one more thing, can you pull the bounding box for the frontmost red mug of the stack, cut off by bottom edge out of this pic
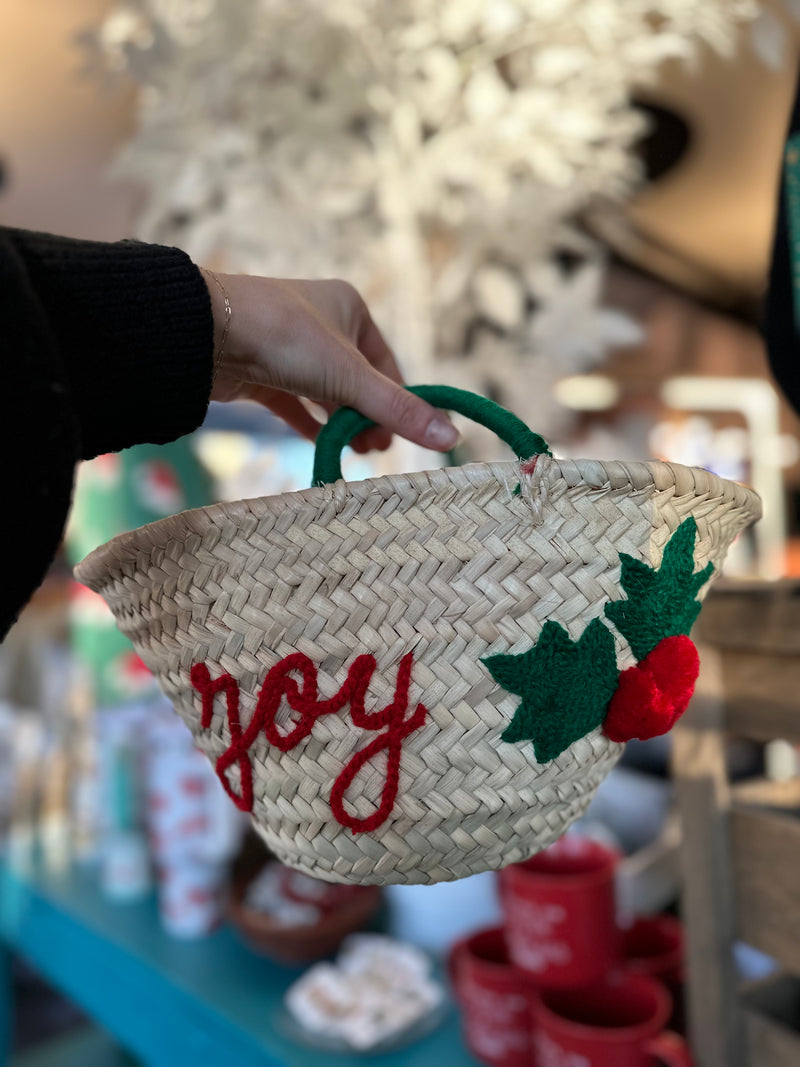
[531,972,692,1067]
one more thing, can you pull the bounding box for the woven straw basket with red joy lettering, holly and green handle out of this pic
[76,386,761,885]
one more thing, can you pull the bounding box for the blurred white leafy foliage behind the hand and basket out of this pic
[87,0,758,446]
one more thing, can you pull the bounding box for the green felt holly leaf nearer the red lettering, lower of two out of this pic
[482,619,619,763]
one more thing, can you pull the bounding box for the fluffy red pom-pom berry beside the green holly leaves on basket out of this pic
[603,634,700,742]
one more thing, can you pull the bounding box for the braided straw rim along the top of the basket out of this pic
[74,457,762,591]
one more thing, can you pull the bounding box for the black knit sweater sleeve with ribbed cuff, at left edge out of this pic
[0,227,213,638]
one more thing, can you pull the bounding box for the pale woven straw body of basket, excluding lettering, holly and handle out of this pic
[77,456,759,883]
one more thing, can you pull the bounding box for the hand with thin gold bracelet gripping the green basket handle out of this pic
[204,271,459,451]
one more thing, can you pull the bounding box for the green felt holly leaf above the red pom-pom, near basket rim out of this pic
[605,519,714,660]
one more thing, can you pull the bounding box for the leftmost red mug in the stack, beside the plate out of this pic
[448,926,533,1067]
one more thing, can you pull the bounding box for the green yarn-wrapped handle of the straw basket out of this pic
[311,385,551,485]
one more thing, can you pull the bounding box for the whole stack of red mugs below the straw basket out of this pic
[449,834,692,1067]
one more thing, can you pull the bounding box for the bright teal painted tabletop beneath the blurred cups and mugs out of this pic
[0,867,477,1067]
